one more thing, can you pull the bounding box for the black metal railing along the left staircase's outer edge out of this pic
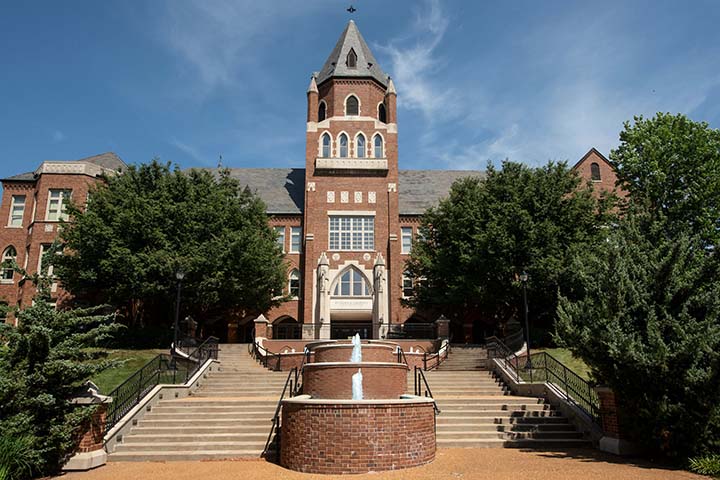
[105,337,218,432]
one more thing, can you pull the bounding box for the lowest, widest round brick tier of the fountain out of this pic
[280,397,435,475]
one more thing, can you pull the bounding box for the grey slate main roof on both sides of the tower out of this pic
[225,168,485,215]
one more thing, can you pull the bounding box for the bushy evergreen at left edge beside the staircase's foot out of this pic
[0,279,118,480]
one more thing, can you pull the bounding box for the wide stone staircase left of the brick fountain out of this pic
[108,345,287,462]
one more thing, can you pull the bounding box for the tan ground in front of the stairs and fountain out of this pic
[58,448,706,480]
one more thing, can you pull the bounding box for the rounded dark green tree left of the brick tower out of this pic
[55,160,286,325]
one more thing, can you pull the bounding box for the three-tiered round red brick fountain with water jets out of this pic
[279,335,435,475]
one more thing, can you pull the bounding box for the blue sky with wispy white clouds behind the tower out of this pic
[0,0,720,177]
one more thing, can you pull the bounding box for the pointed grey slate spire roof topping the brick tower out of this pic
[317,20,388,87]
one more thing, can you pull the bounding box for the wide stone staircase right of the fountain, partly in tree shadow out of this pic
[416,347,591,448]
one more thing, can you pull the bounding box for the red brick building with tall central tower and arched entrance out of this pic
[0,21,616,341]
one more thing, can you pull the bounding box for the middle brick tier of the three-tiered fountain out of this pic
[303,362,408,400]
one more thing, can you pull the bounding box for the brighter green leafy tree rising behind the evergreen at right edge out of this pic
[610,113,720,243]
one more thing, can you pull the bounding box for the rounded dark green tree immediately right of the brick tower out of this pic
[408,161,611,338]
